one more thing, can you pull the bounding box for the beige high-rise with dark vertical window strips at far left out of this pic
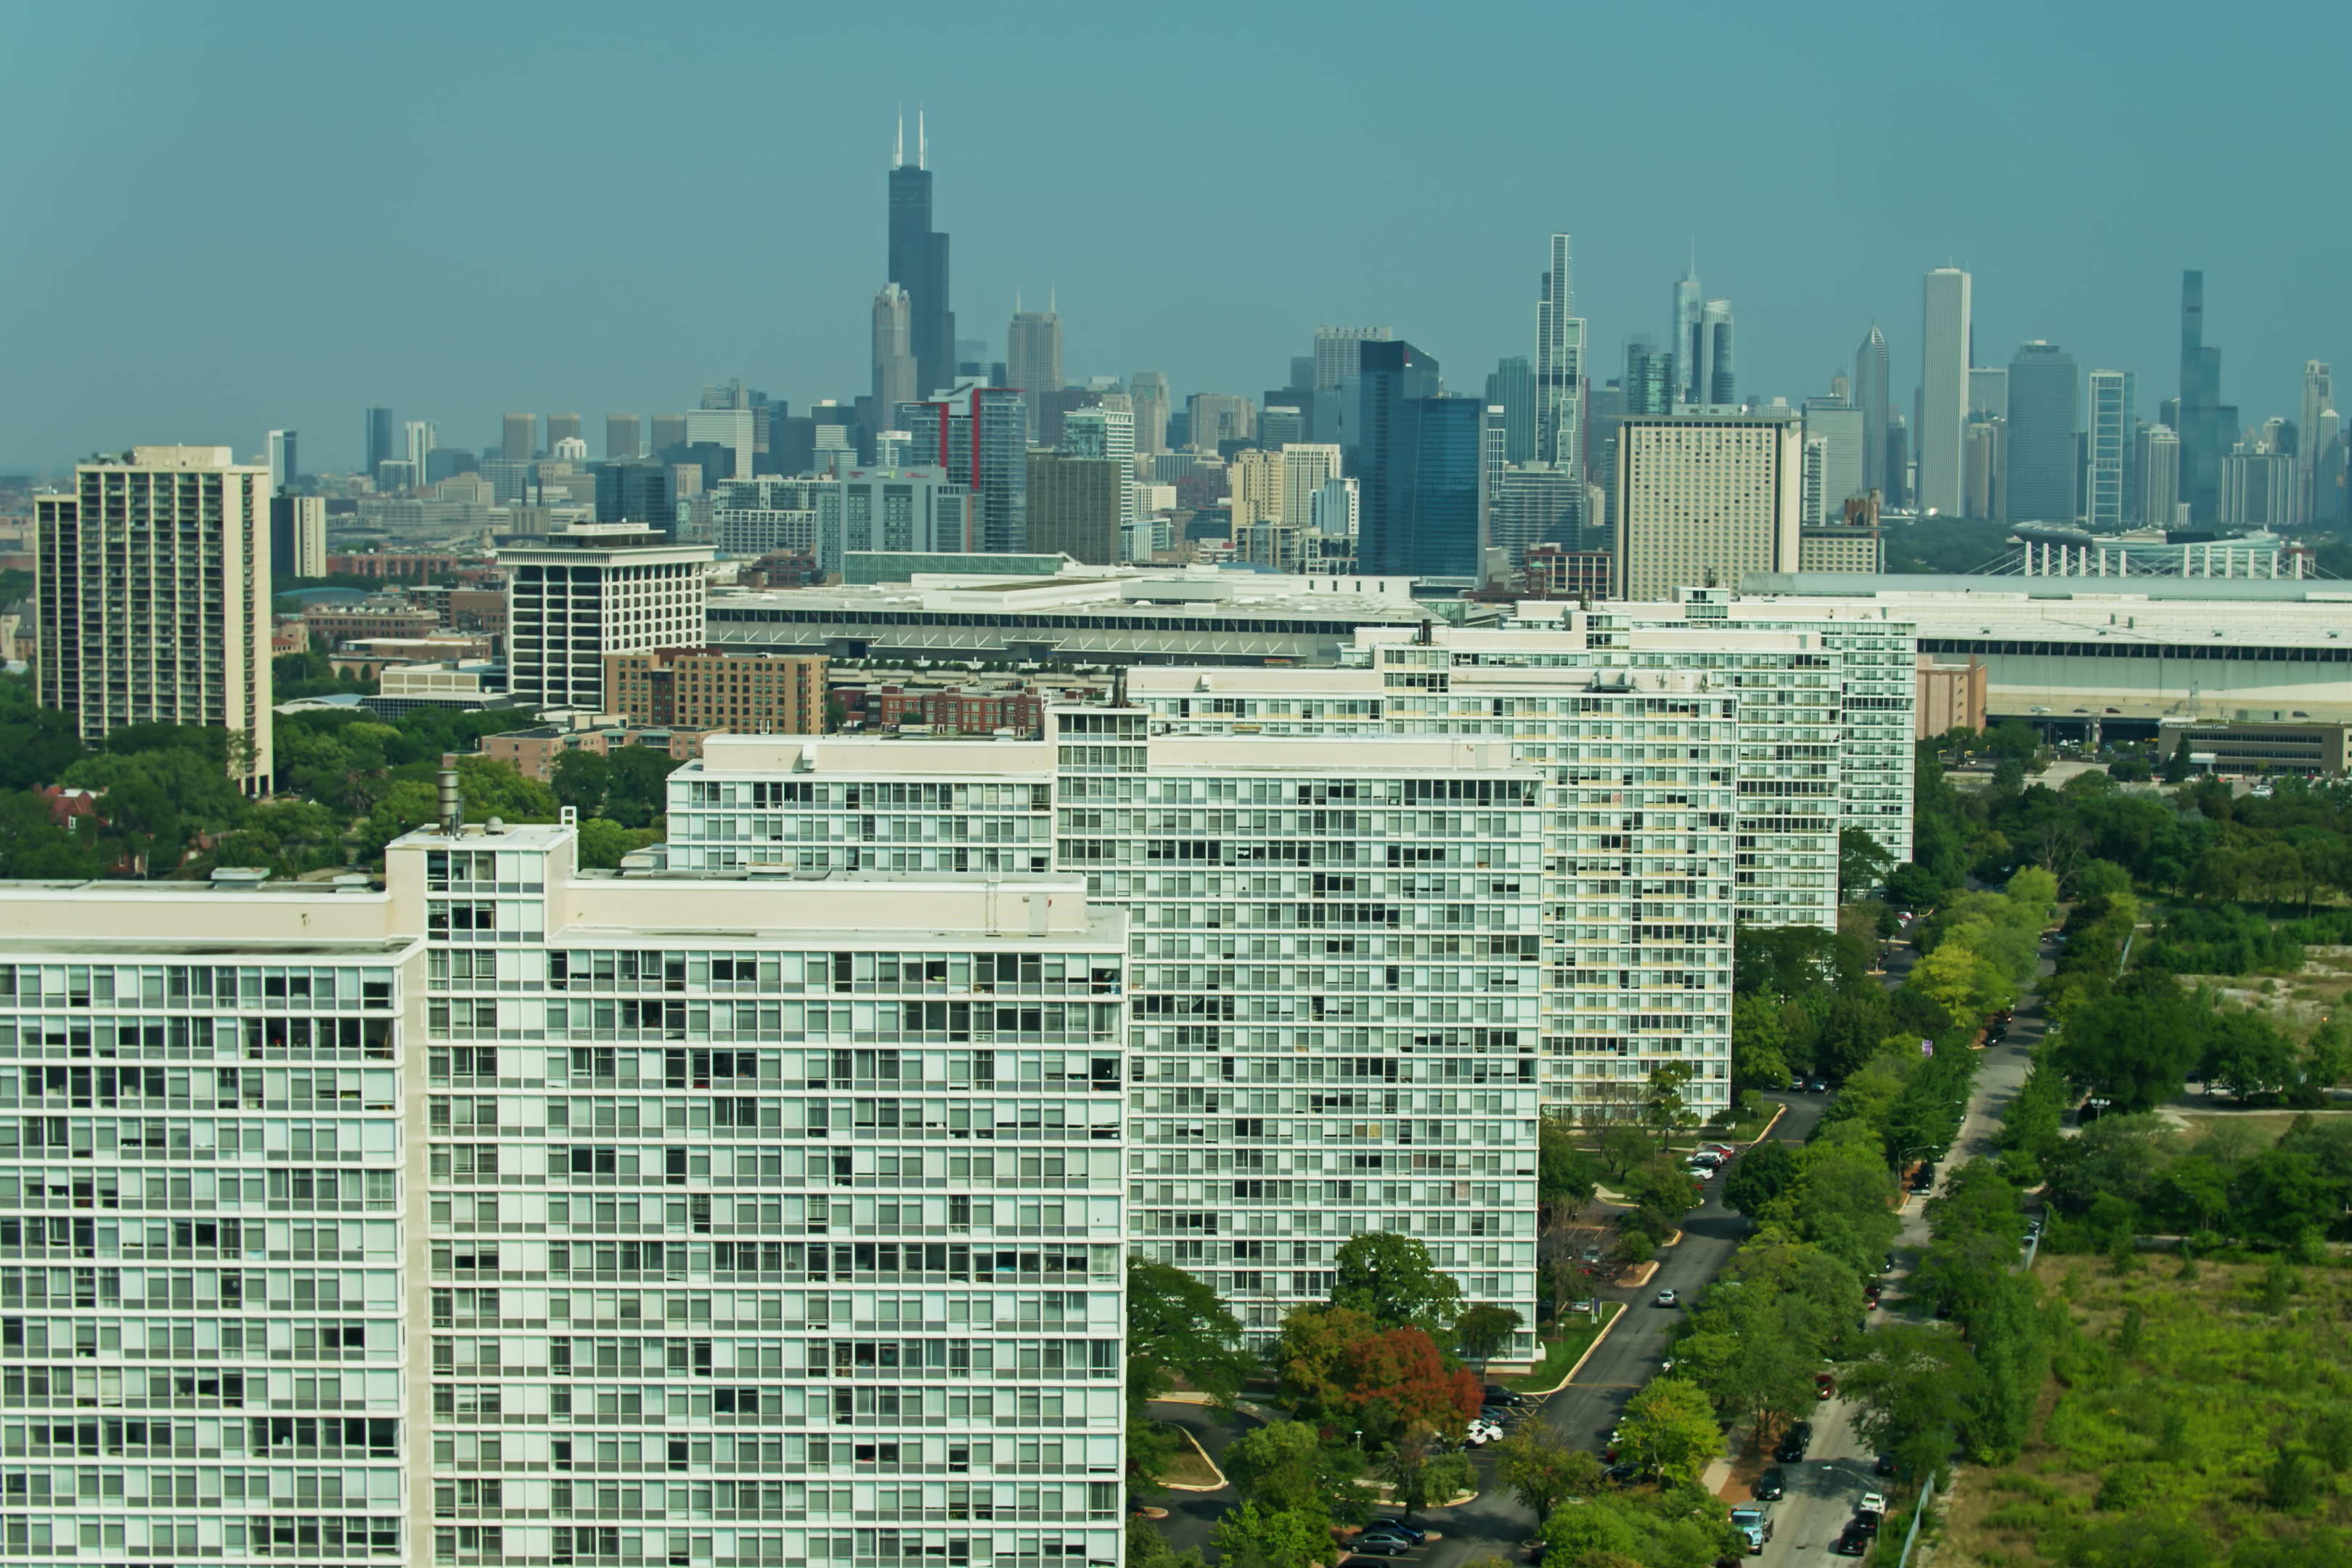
[33,446,273,783]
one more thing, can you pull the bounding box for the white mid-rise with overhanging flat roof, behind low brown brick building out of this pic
[499,522,713,712]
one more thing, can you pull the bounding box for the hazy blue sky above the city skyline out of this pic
[0,0,2352,470]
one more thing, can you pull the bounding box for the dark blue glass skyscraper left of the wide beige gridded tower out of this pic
[1350,338,1487,579]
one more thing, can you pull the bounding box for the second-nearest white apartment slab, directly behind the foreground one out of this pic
[668,724,1540,1357]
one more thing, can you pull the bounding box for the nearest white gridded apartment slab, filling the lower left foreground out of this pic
[0,817,1129,1568]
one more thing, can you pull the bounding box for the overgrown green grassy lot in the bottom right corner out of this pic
[1936,1258,2352,1568]
